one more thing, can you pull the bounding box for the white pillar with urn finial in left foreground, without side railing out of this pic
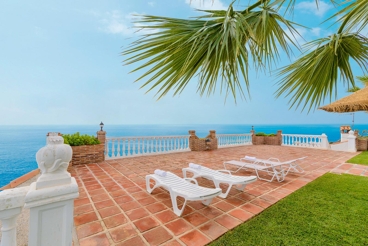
[25,133,79,246]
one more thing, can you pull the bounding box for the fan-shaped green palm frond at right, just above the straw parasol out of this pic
[276,33,368,111]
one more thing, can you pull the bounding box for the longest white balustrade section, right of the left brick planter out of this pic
[105,135,190,160]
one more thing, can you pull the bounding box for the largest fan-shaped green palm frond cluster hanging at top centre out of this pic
[122,2,297,100]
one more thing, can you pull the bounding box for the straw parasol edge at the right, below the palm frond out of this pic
[319,86,368,113]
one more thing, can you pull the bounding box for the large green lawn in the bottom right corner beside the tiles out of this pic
[210,173,368,246]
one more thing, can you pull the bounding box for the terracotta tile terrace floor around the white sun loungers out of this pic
[71,145,368,246]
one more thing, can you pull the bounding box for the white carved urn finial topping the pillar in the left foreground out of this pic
[36,132,73,189]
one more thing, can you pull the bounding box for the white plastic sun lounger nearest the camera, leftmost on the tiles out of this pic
[146,169,222,216]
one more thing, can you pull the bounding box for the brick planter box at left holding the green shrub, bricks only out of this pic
[69,144,105,166]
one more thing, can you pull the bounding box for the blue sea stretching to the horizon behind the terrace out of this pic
[0,124,368,187]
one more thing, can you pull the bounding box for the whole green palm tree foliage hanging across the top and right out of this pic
[122,0,368,110]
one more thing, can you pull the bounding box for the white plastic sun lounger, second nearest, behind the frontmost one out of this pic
[183,163,257,198]
